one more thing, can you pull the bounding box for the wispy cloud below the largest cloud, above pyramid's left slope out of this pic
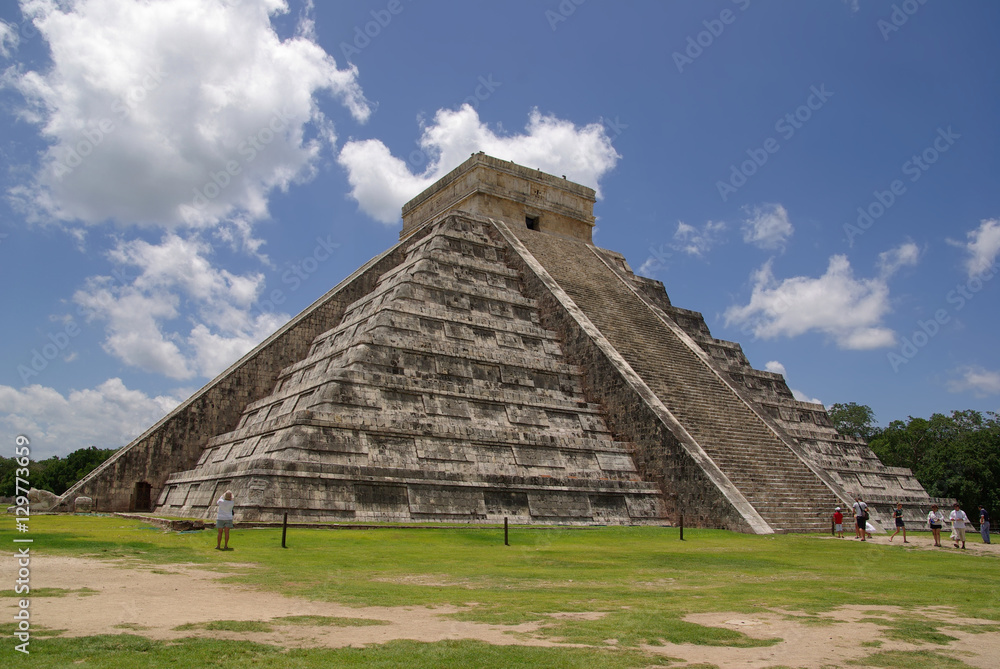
[73,234,288,379]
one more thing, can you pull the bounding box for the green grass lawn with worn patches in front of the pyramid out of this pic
[0,516,1000,669]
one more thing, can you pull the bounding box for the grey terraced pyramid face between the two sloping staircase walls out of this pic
[160,218,662,523]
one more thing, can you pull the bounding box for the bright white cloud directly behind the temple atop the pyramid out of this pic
[338,104,620,224]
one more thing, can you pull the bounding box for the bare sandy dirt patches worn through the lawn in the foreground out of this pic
[0,535,1000,668]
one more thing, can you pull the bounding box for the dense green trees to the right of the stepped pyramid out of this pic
[828,402,1000,518]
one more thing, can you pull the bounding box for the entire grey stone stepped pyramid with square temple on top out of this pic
[56,153,952,533]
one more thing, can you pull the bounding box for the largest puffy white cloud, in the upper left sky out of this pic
[4,0,369,227]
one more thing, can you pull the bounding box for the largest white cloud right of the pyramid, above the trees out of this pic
[725,255,895,349]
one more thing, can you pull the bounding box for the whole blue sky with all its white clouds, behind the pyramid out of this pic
[0,0,1000,458]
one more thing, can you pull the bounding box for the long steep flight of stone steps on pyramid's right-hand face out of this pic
[515,228,843,532]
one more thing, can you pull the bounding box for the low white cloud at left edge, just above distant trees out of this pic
[0,378,180,460]
